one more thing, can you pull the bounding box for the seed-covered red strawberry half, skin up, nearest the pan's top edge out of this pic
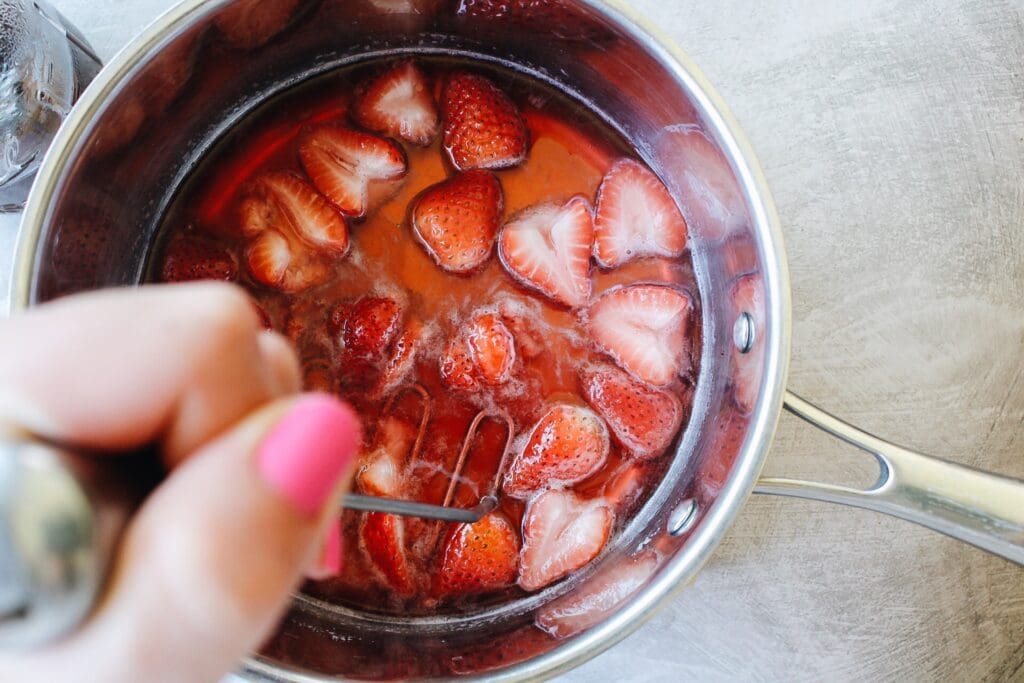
[441,73,529,171]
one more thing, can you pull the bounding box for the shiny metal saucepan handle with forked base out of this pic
[754,391,1024,565]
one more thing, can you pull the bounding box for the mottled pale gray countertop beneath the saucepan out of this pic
[0,0,1024,683]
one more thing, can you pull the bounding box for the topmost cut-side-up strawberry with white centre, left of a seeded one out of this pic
[352,61,439,146]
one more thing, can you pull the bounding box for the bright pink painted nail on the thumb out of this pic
[257,394,361,519]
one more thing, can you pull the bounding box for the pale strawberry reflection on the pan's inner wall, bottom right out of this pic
[537,550,657,639]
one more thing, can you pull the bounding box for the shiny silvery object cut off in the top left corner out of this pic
[0,0,100,211]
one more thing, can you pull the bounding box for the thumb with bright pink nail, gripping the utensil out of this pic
[83,394,360,681]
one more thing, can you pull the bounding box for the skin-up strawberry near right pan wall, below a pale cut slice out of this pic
[584,365,683,460]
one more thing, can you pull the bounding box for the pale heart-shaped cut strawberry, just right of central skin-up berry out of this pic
[498,197,594,308]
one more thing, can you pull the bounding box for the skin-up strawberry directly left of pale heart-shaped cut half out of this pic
[413,171,504,273]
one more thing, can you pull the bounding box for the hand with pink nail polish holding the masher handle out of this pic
[0,284,360,682]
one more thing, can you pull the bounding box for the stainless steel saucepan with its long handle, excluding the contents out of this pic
[12,0,1024,681]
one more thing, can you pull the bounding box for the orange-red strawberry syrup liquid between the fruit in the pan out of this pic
[151,57,699,613]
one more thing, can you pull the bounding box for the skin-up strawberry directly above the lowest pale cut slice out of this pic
[502,405,608,498]
